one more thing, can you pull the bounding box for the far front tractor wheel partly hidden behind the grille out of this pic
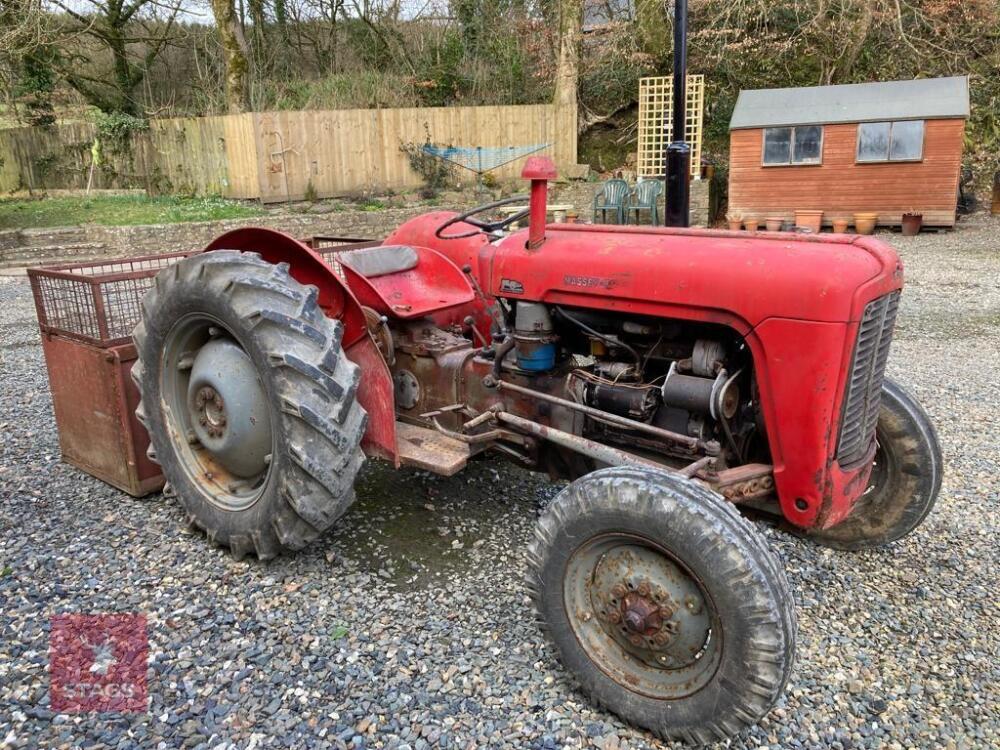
[808,378,944,551]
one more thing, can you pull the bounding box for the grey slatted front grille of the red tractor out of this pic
[837,292,899,466]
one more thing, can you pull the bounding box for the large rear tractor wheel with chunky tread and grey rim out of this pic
[132,251,367,559]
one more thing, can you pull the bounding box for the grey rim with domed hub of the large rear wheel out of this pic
[160,314,274,511]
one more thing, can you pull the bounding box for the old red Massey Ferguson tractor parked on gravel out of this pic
[133,158,942,743]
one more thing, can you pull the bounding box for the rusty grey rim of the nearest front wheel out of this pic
[564,533,722,699]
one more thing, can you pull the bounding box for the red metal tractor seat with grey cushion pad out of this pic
[334,245,475,319]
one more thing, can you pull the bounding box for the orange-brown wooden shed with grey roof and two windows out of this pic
[729,76,969,227]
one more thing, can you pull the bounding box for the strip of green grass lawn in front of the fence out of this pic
[0,195,263,229]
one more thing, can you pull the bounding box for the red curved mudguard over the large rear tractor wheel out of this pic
[205,227,399,466]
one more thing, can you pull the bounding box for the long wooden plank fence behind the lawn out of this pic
[0,104,577,202]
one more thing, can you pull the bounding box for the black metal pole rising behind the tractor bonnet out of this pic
[664,0,691,227]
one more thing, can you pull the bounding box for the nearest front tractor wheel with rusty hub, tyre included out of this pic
[528,467,796,744]
